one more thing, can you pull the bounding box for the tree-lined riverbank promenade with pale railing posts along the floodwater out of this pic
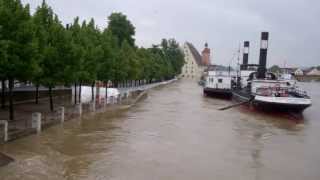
[0,79,176,166]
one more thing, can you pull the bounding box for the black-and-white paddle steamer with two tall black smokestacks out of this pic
[232,32,312,112]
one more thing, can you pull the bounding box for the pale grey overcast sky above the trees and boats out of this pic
[23,0,320,67]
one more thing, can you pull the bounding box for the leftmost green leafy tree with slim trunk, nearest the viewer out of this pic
[0,0,37,120]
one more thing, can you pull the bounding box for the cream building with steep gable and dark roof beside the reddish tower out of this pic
[181,42,206,79]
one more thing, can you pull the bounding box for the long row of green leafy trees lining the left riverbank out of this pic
[0,0,184,120]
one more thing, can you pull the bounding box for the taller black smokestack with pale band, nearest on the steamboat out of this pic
[258,32,269,79]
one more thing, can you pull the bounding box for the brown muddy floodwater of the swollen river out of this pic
[0,81,320,180]
